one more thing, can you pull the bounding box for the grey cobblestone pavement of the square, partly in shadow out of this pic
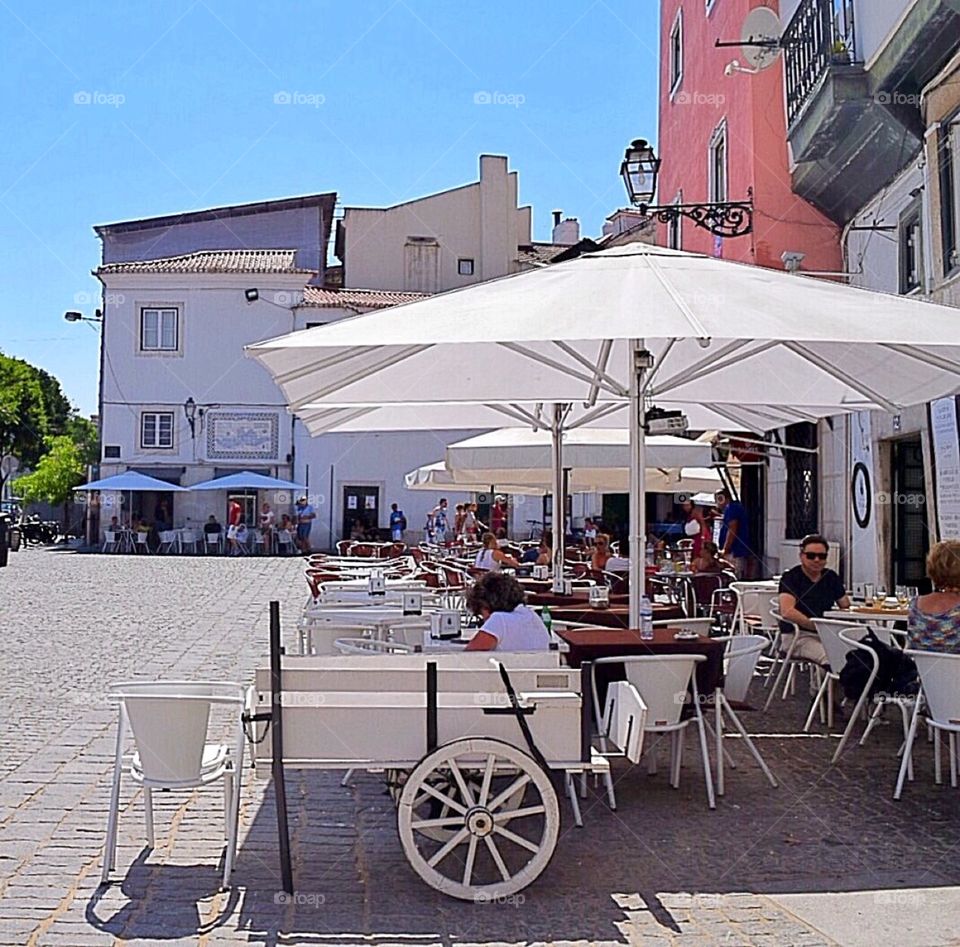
[0,550,960,947]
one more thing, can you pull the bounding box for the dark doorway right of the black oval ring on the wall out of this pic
[891,437,930,591]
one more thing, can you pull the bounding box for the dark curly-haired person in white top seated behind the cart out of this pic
[466,572,550,651]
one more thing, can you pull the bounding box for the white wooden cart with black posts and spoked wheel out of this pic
[249,608,644,902]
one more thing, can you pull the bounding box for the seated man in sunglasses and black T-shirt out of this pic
[779,533,850,664]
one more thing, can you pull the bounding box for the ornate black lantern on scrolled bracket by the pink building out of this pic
[620,138,753,237]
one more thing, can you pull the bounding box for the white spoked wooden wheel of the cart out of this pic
[397,737,560,901]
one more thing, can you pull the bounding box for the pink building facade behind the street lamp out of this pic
[656,0,843,273]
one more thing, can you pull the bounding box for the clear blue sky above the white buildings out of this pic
[0,0,658,413]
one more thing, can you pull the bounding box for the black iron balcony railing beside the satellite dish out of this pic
[783,0,856,126]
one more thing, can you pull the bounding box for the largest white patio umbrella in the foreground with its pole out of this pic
[249,244,960,623]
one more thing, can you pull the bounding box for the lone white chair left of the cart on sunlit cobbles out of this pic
[101,681,246,887]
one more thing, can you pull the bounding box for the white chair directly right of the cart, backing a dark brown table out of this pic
[592,654,717,809]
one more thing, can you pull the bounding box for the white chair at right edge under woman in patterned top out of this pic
[893,648,960,799]
